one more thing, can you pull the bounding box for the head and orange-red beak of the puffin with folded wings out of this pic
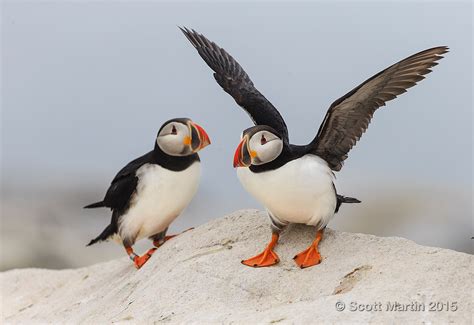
[156,118,211,157]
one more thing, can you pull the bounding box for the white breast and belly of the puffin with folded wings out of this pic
[119,162,201,242]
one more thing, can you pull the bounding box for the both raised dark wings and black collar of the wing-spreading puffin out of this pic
[180,28,448,172]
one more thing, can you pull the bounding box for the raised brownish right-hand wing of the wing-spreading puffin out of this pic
[308,46,448,171]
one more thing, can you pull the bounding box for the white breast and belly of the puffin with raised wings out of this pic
[237,155,336,225]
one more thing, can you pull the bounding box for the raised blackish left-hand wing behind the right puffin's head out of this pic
[180,27,288,140]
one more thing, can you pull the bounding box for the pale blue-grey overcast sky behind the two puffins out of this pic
[1,1,472,256]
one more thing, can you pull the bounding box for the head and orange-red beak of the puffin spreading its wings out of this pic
[234,125,283,167]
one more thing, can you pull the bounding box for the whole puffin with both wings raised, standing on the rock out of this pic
[180,28,448,268]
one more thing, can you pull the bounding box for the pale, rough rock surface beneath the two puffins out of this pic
[0,210,473,324]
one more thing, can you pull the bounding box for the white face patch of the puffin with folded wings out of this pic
[156,122,191,156]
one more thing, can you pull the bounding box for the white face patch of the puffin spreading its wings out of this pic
[248,131,283,165]
